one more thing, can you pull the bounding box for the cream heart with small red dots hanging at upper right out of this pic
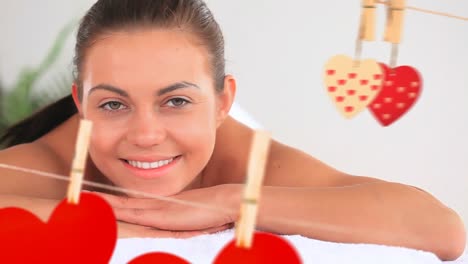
[324,55,384,118]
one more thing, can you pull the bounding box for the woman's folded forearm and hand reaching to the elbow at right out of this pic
[90,179,465,260]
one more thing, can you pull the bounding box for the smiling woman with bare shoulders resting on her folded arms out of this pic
[0,0,465,260]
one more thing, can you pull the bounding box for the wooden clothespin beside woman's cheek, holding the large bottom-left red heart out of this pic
[67,119,92,204]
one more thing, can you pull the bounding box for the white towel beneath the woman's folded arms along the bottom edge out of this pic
[111,229,468,264]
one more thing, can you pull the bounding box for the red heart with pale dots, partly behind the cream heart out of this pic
[367,63,422,126]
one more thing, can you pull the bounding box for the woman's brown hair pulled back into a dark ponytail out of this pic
[0,0,225,147]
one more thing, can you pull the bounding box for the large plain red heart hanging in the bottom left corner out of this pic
[0,193,117,263]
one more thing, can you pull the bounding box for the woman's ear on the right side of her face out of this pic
[216,75,237,127]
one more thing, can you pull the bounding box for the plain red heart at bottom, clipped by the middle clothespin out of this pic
[214,232,302,264]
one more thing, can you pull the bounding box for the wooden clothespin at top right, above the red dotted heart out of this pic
[384,0,406,44]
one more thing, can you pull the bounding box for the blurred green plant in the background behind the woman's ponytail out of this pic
[0,22,76,135]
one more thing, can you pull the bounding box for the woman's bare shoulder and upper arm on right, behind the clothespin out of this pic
[207,117,380,187]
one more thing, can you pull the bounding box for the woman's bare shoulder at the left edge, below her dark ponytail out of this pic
[0,141,66,199]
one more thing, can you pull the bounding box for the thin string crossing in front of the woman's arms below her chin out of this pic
[0,163,322,230]
